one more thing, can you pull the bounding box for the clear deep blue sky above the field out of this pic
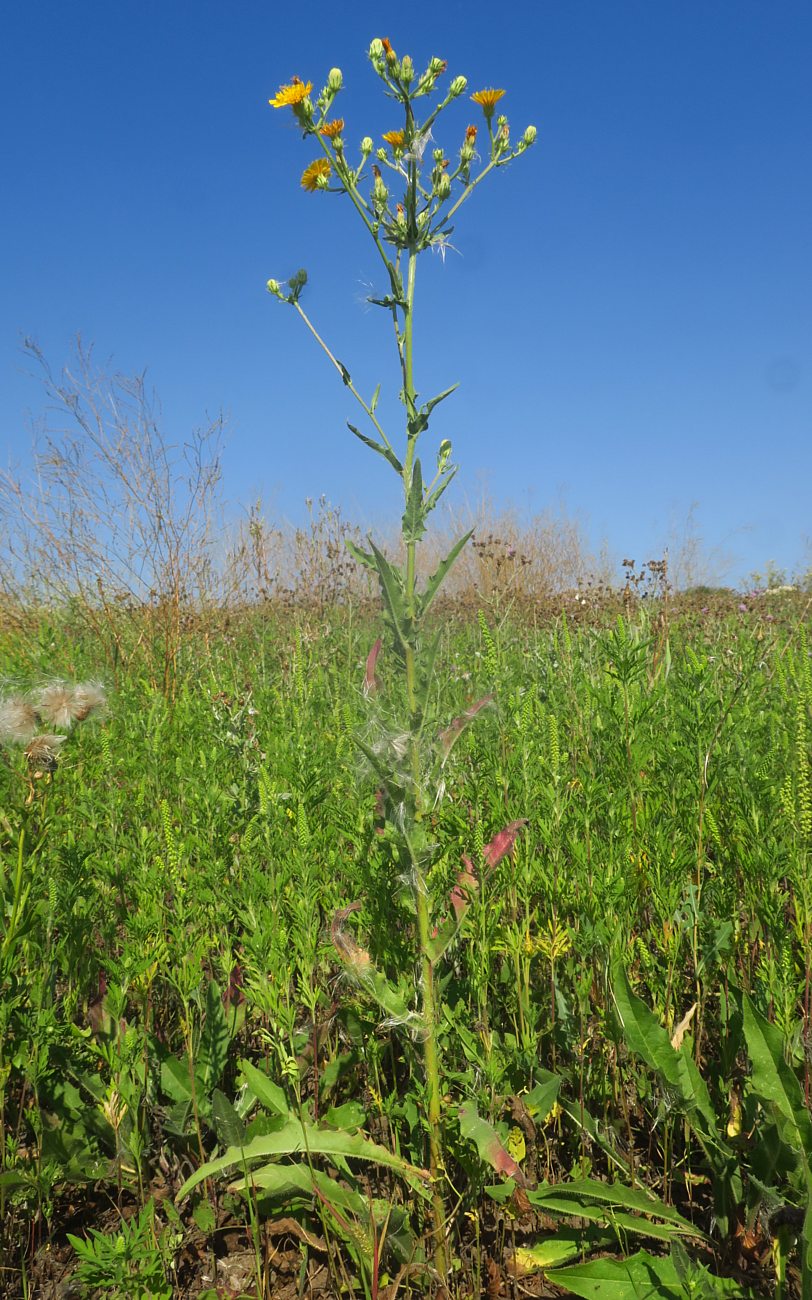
[0,0,812,580]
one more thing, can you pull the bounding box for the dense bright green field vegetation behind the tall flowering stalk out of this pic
[0,607,812,1295]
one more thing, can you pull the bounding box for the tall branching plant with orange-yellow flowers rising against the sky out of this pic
[268,39,535,1277]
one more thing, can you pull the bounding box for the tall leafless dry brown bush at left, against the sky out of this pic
[0,339,222,696]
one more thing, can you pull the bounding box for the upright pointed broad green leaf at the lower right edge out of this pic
[742,996,812,1170]
